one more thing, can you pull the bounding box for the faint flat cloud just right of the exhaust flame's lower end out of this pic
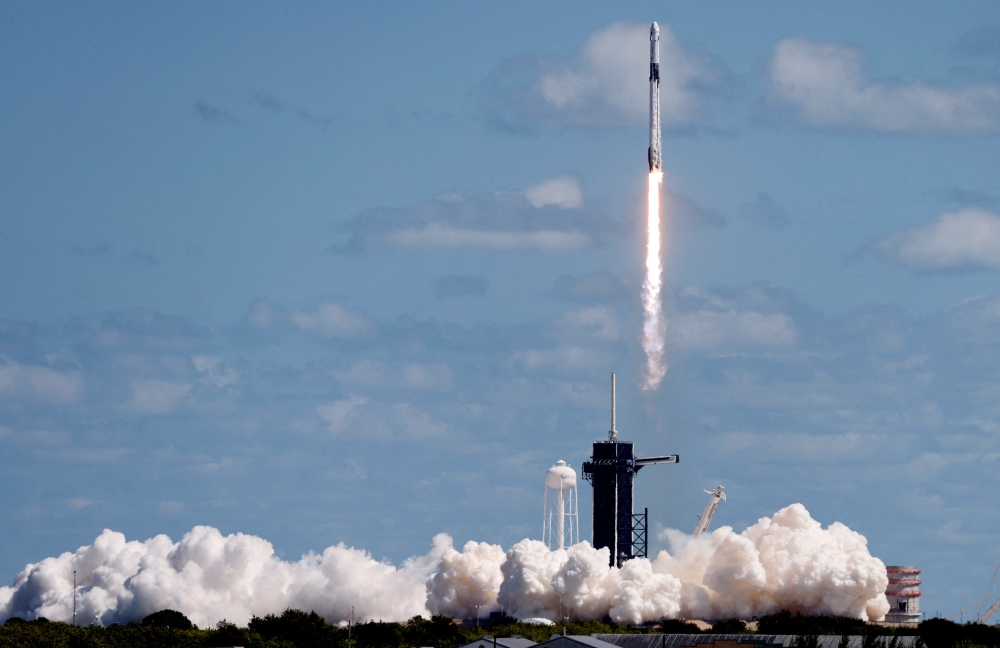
[667,310,798,351]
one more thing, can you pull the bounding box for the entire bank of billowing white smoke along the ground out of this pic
[0,504,889,627]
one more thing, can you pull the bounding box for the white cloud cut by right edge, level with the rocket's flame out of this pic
[874,207,1000,270]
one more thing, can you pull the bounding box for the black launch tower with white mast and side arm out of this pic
[583,374,680,567]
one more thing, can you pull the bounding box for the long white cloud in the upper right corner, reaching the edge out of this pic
[770,37,1000,135]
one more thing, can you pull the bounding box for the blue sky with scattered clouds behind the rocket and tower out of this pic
[0,2,1000,614]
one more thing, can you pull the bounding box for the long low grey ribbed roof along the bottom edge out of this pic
[592,634,919,648]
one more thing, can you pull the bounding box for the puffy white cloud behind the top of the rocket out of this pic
[529,23,710,126]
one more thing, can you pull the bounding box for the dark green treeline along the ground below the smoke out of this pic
[0,610,1000,648]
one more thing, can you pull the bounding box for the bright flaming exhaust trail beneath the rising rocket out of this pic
[642,171,667,390]
